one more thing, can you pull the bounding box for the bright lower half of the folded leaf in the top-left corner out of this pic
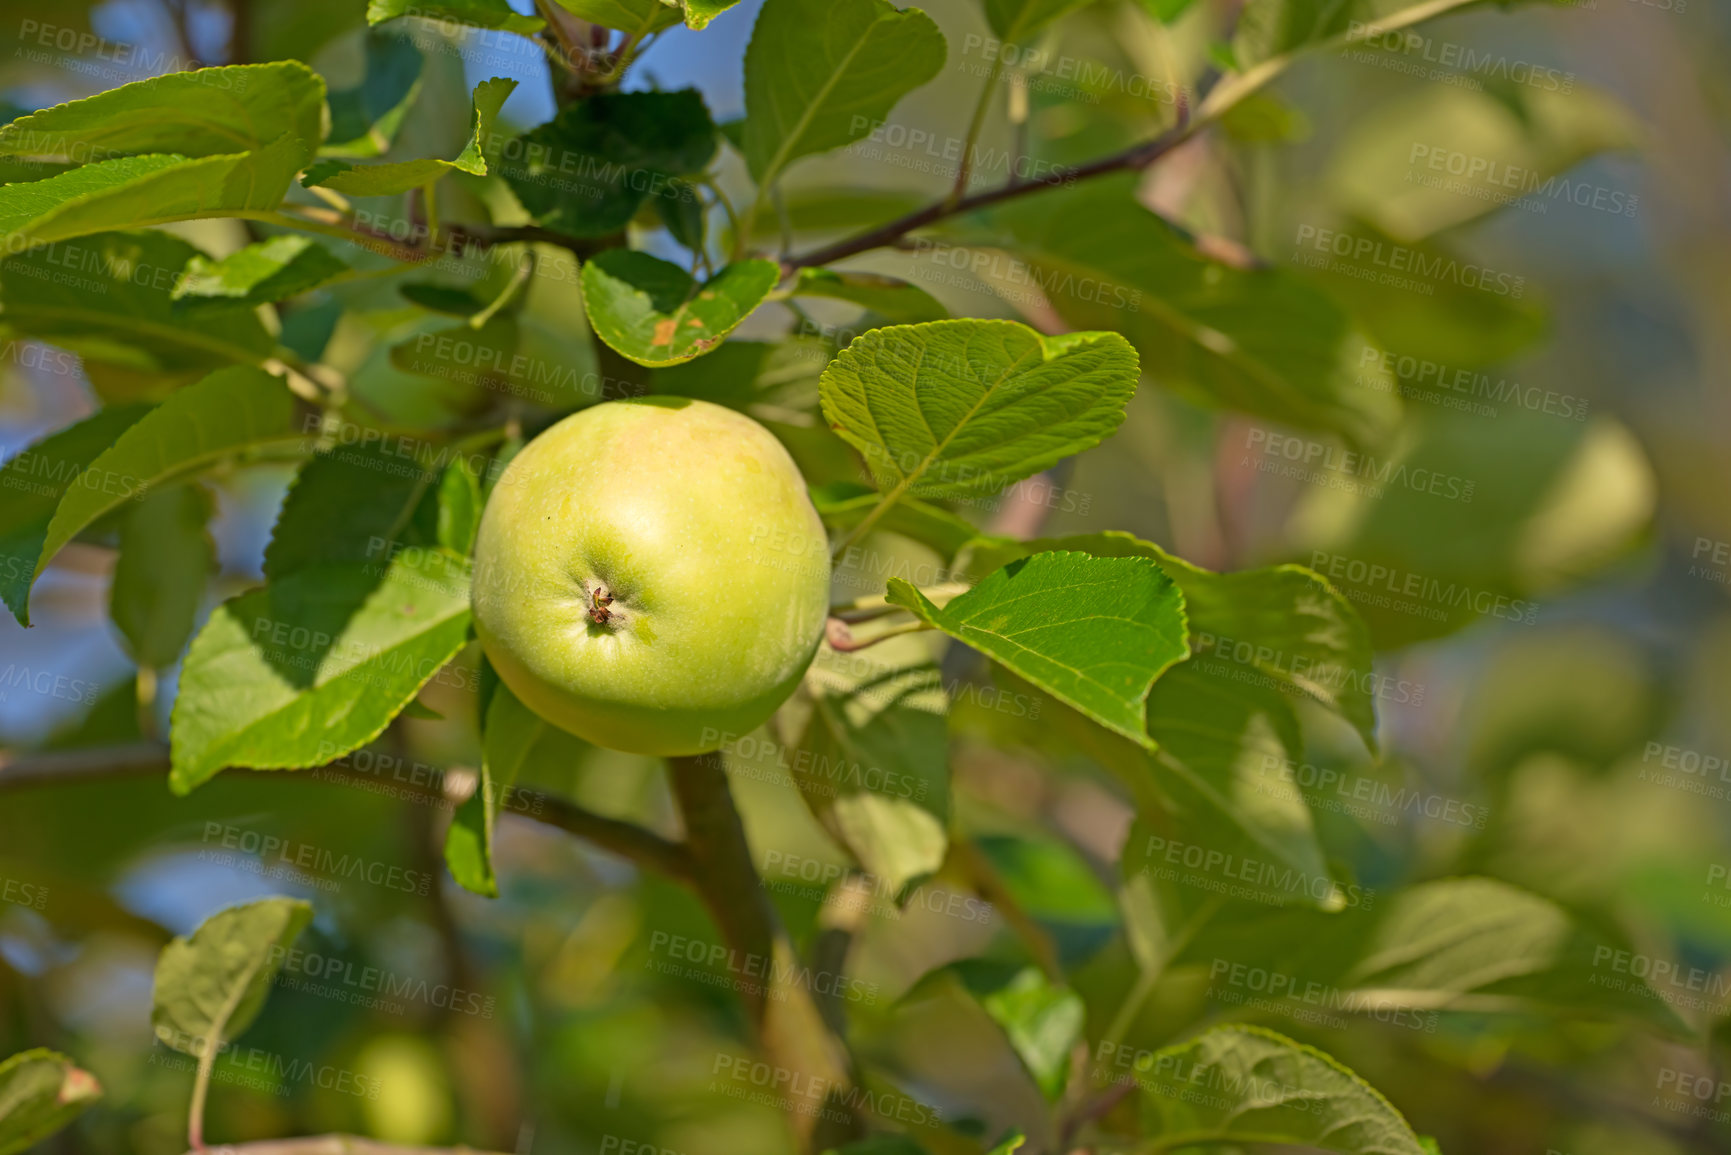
[0,135,306,253]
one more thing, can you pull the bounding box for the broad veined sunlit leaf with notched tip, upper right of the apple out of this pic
[820,320,1137,500]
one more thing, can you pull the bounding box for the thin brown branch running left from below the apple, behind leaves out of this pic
[0,743,691,880]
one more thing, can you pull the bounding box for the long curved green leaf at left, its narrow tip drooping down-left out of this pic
[14,367,301,625]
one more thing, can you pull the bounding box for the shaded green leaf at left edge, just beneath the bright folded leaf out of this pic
[0,230,272,398]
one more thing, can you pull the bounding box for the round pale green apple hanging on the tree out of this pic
[473,397,829,757]
